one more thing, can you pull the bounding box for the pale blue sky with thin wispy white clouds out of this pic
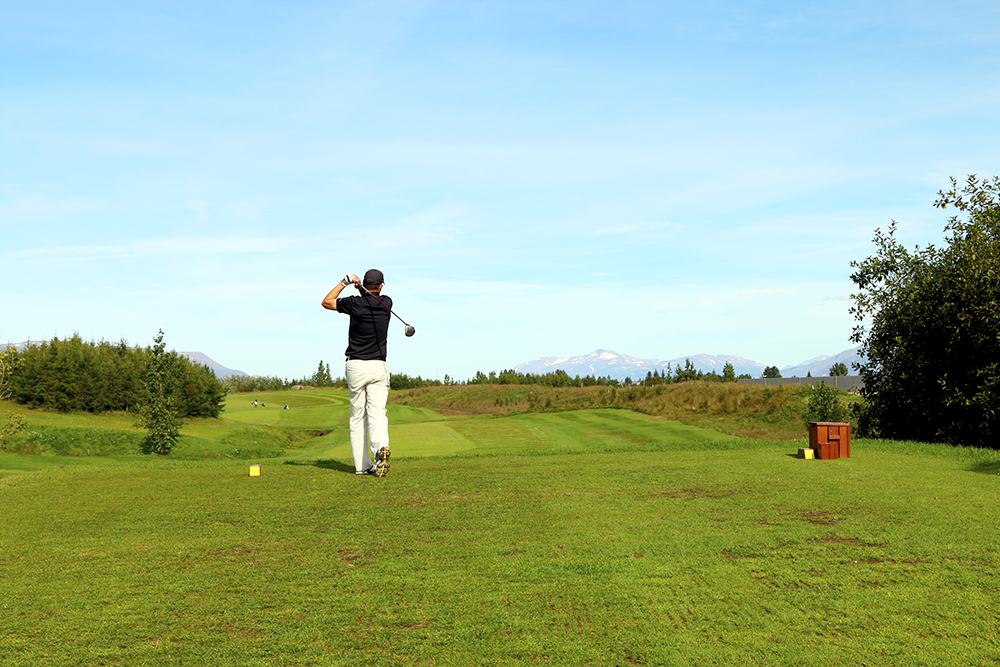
[0,0,1000,379]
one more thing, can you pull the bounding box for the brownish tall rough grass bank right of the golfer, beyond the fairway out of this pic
[390,381,809,439]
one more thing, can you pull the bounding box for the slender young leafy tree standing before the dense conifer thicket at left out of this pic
[139,329,181,455]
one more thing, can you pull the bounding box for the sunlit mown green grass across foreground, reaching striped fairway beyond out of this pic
[0,393,1000,665]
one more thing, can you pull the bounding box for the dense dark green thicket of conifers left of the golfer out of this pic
[7,334,225,418]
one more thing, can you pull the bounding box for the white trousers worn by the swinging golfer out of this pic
[345,359,389,472]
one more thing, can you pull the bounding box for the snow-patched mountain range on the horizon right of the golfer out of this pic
[514,348,858,380]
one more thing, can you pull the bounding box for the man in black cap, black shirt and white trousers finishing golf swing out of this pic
[323,269,392,477]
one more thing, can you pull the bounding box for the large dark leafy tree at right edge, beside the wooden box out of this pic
[851,176,1000,448]
